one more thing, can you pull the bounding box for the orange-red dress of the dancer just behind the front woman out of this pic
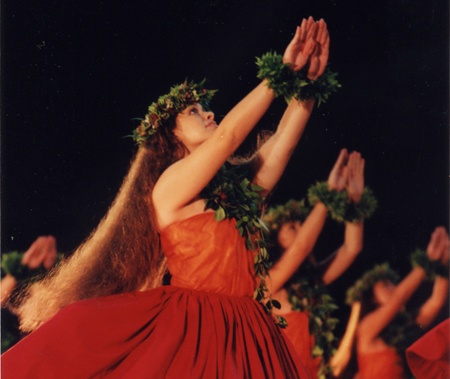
[283,311,320,378]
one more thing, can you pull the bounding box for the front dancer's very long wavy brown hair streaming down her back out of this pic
[17,119,186,332]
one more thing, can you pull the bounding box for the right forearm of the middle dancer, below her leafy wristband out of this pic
[322,222,364,284]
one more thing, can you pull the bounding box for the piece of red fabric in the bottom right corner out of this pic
[406,319,450,379]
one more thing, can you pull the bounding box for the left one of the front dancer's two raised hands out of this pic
[283,17,318,71]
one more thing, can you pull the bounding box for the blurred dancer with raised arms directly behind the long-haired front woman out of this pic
[264,149,367,378]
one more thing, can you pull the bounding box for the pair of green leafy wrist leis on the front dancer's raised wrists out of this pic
[256,52,341,106]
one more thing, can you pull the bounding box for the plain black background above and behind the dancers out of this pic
[1,0,449,326]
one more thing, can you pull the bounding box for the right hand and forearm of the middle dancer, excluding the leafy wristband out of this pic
[322,152,365,284]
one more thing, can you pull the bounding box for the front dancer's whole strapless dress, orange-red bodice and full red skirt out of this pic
[1,213,309,379]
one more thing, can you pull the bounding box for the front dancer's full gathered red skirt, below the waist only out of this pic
[2,286,309,379]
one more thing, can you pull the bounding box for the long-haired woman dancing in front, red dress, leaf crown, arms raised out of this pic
[2,18,338,378]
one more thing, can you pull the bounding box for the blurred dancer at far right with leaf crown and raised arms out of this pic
[348,227,449,379]
